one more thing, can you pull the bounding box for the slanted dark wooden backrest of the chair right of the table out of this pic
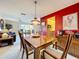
[61,34,73,59]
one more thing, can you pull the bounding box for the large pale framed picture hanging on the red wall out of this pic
[63,12,78,30]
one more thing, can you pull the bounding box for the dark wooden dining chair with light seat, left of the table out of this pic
[18,32,34,59]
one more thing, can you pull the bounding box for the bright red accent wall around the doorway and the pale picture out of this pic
[41,3,79,31]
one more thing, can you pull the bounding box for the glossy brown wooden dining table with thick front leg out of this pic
[24,36,54,59]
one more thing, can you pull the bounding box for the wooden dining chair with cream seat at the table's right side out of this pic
[43,34,73,59]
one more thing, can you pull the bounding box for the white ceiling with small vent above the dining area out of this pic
[0,0,79,22]
